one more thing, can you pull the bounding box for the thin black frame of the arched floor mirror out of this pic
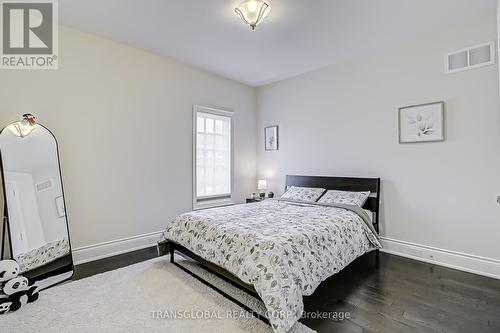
[0,122,75,290]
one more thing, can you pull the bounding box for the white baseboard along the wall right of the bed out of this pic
[380,237,500,279]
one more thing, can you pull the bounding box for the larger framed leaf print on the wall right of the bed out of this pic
[398,102,445,143]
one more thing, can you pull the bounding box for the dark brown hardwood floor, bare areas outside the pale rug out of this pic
[74,247,500,333]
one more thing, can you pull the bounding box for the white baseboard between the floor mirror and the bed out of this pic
[72,231,162,265]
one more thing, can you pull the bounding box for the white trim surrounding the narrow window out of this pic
[193,104,234,210]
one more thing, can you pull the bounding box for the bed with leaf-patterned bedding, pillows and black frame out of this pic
[158,176,381,333]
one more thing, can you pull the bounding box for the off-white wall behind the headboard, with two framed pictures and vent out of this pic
[257,15,500,276]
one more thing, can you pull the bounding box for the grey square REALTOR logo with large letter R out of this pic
[0,0,58,69]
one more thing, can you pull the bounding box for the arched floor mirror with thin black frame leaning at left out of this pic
[0,114,73,289]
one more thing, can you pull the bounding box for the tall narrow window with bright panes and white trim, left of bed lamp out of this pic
[193,105,233,209]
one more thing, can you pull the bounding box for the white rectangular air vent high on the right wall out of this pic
[445,42,495,73]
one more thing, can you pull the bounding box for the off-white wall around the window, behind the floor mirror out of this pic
[0,27,256,260]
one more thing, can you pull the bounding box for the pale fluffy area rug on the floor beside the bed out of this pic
[0,256,314,333]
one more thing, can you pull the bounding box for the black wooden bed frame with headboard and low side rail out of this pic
[168,175,380,324]
